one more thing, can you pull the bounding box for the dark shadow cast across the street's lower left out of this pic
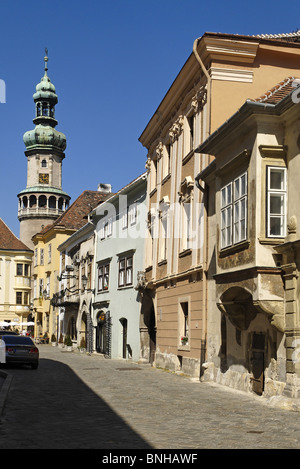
[0,358,151,449]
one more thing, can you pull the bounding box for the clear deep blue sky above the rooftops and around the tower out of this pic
[0,0,300,236]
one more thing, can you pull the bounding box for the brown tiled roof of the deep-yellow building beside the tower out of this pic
[34,191,111,234]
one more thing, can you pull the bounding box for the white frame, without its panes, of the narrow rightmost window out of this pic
[266,166,287,238]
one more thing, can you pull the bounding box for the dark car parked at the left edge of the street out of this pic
[1,334,39,370]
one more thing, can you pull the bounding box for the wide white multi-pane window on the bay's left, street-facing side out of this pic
[221,173,247,248]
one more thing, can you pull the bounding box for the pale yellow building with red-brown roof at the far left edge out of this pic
[0,218,33,330]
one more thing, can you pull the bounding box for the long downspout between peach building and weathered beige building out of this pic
[193,37,211,379]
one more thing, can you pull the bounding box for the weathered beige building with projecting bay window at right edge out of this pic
[197,77,300,397]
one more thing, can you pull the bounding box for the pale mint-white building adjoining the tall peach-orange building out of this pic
[91,174,147,361]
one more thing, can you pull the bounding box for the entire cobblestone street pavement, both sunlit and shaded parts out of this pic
[0,345,300,450]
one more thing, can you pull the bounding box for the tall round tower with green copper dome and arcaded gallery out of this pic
[18,50,70,249]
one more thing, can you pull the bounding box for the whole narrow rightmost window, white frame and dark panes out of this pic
[267,166,286,238]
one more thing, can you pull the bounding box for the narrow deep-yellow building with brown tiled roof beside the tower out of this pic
[32,191,107,340]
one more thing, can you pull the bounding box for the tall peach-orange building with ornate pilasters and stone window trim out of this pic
[140,33,300,376]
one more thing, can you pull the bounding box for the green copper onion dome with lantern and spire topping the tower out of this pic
[23,49,67,151]
